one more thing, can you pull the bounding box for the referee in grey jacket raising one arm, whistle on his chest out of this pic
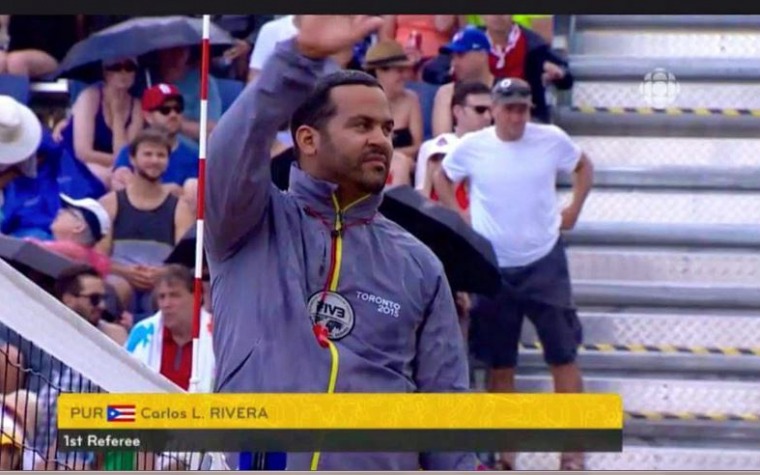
[204,15,478,470]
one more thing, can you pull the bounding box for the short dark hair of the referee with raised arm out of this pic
[290,69,383,156]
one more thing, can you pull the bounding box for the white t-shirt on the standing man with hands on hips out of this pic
[442,123,581,267]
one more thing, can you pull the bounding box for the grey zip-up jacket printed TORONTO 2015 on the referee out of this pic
[205,40,477,470]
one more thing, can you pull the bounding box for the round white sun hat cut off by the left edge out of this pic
[0,95,42,165]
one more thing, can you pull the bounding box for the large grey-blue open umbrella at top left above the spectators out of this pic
[54,15,234,79]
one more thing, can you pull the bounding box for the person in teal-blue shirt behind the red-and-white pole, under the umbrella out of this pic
[156,46,222,149]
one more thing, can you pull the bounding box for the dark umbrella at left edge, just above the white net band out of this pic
[0,235,89,292]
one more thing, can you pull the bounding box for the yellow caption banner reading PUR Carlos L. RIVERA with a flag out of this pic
[58,393,623,429]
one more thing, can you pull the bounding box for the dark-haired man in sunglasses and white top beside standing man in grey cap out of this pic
[414,82,493,203]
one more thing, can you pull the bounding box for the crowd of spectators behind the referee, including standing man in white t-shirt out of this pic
[0,15,592,469]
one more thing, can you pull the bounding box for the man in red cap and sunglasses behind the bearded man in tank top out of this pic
[111,84,198,196]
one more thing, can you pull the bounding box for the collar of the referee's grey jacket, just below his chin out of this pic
[288,163,383,220]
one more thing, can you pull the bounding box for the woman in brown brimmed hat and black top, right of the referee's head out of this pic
[364,40,423,185]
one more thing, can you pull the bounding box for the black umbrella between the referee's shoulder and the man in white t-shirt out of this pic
[380,185,501,295]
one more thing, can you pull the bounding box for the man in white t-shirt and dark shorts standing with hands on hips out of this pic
[435,78,593,470]
